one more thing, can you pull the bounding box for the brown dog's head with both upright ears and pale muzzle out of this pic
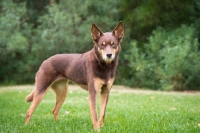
[91,22,124,64]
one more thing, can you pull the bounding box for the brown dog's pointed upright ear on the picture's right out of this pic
[112,21,124,41]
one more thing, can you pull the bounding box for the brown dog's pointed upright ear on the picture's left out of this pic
[91,23,103,42]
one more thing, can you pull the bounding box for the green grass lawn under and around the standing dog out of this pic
[0,86,200,133]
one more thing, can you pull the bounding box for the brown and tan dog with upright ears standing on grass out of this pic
[25,21,124,129]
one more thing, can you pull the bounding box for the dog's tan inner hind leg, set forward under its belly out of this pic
[51,80,68,120]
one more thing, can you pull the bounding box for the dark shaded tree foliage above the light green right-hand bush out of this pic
[120,0,200,43]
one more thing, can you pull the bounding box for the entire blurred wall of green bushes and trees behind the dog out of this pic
[0,0,200,90]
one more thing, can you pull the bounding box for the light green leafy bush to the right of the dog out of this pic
[126,25,200,90]
